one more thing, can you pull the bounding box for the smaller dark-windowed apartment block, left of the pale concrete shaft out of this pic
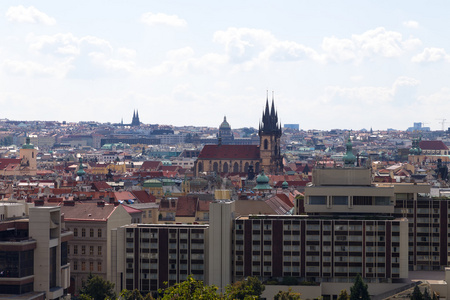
[112,224,209,292]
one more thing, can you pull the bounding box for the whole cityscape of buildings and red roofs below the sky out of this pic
[0,99,450,299]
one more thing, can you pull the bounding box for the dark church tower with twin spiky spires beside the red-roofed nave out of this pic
[259,95,283,174]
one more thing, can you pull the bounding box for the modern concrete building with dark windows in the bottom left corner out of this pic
[0,207,72,299]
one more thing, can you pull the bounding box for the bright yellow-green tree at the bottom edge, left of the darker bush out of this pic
[159,275,221,300]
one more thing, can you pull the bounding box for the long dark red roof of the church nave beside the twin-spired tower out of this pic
[198,145,260,160]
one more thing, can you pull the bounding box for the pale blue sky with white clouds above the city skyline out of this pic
[0,0,450,130]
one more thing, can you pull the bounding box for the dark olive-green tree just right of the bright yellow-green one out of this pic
[225,277,265,300]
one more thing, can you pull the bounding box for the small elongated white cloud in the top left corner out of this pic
[6,5,56,26]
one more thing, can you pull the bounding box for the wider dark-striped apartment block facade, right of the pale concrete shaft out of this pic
[233,215,408,283]
